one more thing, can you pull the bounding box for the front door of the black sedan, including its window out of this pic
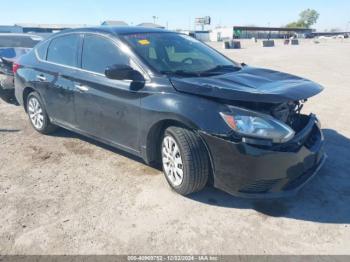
[75,34,140,152]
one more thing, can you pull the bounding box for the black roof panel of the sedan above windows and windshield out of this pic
[55,26,174,35]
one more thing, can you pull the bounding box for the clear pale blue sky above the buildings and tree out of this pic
[0,0,350,31]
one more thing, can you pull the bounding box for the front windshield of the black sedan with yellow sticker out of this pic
[122,33,240,76]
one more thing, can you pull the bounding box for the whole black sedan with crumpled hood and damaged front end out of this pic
[15,27,325,197]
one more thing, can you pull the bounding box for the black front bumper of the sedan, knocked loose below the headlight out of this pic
[200,115,326,198]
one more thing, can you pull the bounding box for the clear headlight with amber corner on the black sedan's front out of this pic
[221,110,295,143]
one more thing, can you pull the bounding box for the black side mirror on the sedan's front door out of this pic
[105,64,145,82]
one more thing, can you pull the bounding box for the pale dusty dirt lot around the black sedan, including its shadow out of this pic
[0,40,350,254]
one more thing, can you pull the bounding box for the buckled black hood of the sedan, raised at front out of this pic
[170,66,323,103]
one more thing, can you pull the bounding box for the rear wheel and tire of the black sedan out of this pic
[26,92,57,135]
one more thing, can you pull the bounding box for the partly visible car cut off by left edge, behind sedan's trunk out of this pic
[0,34,43,100]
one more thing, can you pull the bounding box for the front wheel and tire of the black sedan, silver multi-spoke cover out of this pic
[161,127,210,195]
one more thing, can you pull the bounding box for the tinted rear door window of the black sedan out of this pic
[47,34,80,67]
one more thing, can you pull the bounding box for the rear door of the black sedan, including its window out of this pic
[41,34,81,127]
